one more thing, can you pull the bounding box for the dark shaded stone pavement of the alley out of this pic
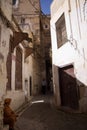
[15,96,87,130]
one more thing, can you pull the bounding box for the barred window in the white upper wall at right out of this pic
[56,14,67,48]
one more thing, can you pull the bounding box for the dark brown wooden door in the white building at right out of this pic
[59,66,78,109]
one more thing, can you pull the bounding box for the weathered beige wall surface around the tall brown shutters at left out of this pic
[0,0,28,110]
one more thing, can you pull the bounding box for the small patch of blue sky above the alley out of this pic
[40,0,53,14]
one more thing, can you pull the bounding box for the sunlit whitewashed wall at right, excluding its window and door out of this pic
[50,0,87,112]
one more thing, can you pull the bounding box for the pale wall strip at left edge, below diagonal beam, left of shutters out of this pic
[0,18,10,98]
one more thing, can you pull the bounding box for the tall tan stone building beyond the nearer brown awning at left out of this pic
[14,0,41,95]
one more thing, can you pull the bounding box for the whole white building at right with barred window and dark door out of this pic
[51,0,87,111]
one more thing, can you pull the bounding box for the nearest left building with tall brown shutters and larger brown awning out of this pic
[0,0,31,130]
